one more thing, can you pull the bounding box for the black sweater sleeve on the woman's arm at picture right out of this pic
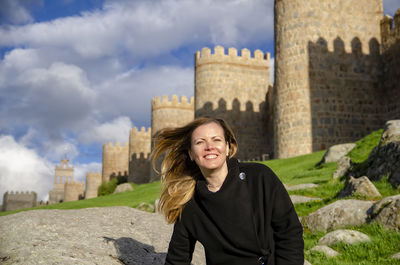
[271,177,304,265]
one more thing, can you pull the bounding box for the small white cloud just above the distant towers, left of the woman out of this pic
[80,117,132,143]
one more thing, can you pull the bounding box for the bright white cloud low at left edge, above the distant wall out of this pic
[0,135,54,202]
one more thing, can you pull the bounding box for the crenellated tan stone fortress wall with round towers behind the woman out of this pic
[76,0,400,196]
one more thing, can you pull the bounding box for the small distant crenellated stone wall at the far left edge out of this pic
[2,191,37,212]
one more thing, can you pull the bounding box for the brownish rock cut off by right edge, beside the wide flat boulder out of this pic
[373,195,400,231]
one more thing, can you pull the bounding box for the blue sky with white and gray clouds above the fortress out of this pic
[0,0,400,204]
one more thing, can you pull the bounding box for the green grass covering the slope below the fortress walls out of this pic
[0,128,400,265]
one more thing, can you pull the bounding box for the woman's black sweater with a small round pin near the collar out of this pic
[165,159,304,265]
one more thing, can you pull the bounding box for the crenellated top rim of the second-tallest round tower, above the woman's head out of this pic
[195,46,271,67]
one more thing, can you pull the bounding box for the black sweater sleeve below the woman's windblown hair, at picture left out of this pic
[165,220,196,265]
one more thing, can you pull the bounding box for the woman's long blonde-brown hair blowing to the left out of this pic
[152,117,237,223]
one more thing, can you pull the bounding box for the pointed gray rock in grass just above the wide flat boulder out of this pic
[339,176,382,198]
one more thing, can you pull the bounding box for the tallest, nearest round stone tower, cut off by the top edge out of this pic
[274,0,384,158]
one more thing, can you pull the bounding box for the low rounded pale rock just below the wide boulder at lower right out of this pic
[318,229,371,246]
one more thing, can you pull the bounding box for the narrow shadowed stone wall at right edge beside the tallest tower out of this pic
[381,9,400,120]
